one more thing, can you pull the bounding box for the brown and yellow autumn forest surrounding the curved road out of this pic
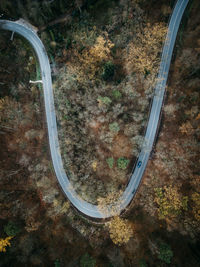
[0,0,200,267]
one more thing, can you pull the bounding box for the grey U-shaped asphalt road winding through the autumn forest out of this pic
[0,0,189,218]
